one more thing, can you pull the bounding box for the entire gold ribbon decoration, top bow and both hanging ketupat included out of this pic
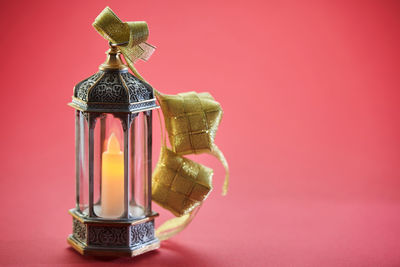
[93,7,229,240]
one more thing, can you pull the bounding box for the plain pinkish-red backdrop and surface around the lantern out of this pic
[0,0,400,266]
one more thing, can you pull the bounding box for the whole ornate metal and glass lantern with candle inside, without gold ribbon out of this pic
[68,45,160,256]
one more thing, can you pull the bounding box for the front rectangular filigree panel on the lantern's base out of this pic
[89,225,129,247]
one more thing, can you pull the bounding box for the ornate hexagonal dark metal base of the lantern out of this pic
[67,210,160,257]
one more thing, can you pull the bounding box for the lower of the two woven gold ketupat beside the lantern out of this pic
[152,147,213,216]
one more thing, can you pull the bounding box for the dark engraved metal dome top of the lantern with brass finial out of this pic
[69,45,158,113]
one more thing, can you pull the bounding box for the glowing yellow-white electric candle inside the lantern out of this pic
[101,133,124,218]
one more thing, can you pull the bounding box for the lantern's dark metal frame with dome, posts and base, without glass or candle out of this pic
[67,44,160,256]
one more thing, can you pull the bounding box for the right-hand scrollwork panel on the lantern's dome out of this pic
[120,72,153,103]
